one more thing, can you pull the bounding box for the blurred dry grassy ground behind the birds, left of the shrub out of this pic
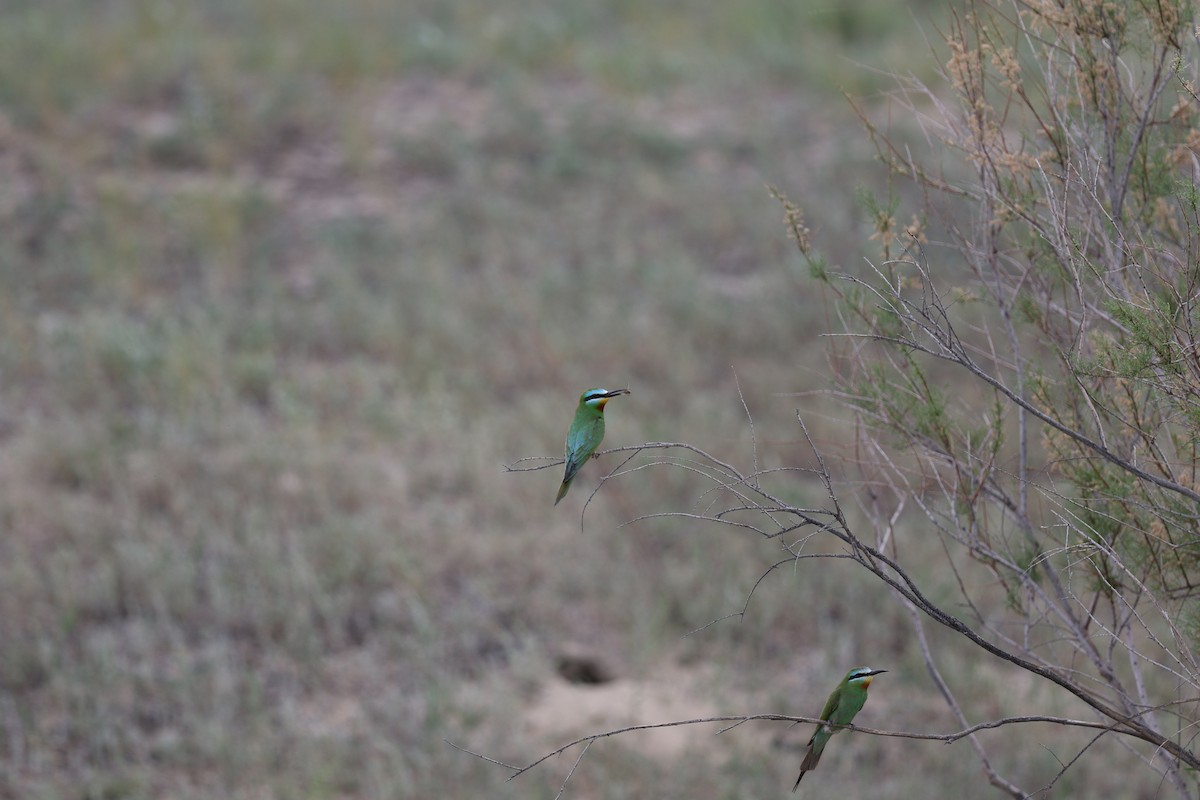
[0,0,1132,800]
